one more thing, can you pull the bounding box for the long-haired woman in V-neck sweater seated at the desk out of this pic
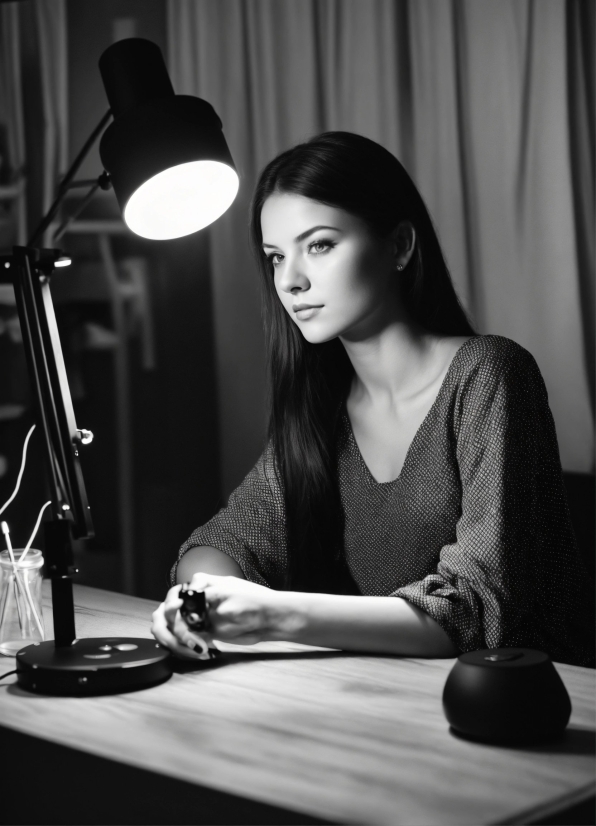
[152,132,592,664]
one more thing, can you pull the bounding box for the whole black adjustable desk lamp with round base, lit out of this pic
[0,38,239,695]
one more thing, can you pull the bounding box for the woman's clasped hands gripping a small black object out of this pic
[151,573,278,659]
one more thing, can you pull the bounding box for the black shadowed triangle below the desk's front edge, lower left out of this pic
[0,727,330,826]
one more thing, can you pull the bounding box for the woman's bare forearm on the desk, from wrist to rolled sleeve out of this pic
[271,591,459,657]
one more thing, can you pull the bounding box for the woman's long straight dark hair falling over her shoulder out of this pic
[250,132,474,592]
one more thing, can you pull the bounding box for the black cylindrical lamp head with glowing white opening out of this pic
[99,38,239,240]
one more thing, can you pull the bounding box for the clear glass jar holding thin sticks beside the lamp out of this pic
[0,548,44,657]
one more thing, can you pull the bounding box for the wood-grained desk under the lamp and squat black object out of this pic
[0,583,594,826]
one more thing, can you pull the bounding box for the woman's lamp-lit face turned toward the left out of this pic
[261,193,398,344]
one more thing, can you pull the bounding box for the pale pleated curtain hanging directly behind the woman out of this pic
[168,0,594,494]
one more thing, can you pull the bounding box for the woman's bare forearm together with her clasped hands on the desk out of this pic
[151,572,458,657]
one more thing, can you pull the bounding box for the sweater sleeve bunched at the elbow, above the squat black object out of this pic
[392,342,585,662]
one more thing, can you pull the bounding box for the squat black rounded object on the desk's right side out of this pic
[443,648,571,743]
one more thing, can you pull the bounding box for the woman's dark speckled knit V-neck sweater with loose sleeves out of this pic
[171,335,594,665]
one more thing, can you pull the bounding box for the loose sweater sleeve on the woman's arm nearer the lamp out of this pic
[170,445,287,588]
